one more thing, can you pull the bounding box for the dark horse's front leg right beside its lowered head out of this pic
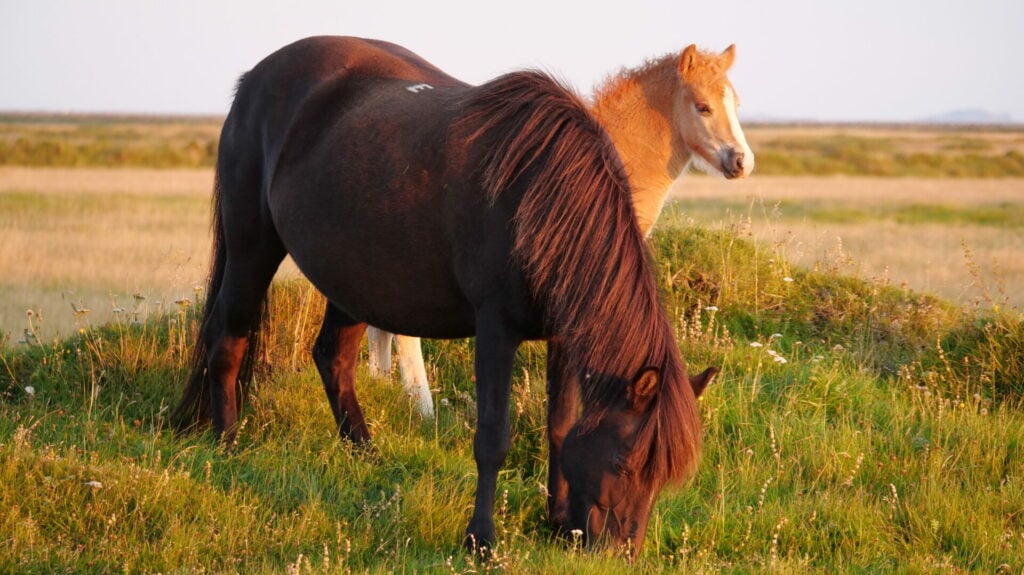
[548,340,580,529]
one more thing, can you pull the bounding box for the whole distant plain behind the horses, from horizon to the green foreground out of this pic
[0,118,1024,342]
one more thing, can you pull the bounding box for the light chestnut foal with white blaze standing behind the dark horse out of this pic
[367,44,754,417]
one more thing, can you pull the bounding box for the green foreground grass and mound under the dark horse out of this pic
[0,223,1024,573]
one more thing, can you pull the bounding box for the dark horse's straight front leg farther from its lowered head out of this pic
[465,314,521,552]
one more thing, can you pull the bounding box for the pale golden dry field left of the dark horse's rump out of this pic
[0,167,294,343]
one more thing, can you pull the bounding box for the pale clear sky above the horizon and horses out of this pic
[0,0,1024,122]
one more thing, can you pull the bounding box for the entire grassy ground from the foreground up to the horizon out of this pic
[0,119,1024,575]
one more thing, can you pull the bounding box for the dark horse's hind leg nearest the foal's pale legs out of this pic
[313,303,370,443]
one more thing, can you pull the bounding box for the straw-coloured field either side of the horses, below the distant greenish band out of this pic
[0,154,1024,342]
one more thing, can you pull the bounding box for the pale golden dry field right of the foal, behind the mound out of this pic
[669,176,1024,307]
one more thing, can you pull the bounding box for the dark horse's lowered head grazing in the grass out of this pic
[561,367,718,550]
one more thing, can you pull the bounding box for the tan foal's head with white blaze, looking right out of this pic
[673,44,754,179]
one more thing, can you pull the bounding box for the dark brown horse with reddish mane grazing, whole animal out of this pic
[175,37,710,548]
